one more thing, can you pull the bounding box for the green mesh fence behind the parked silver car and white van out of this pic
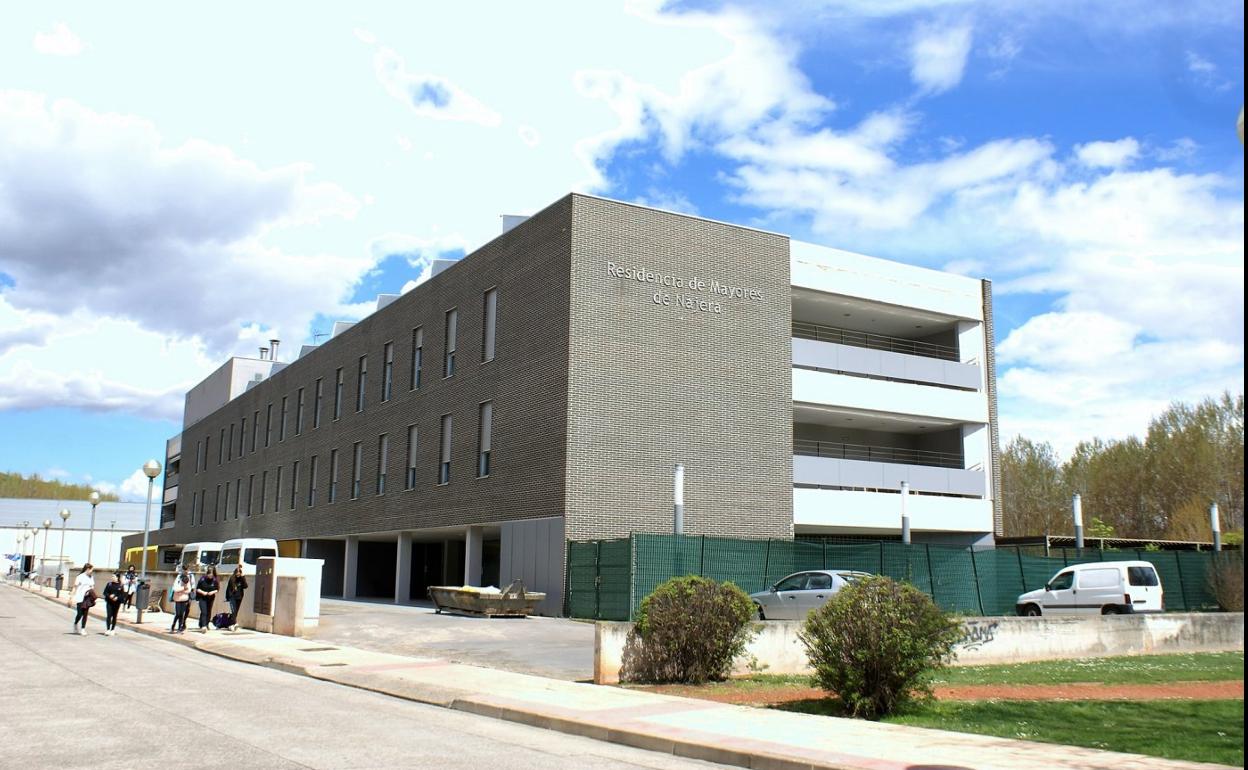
[564,534,1242,620]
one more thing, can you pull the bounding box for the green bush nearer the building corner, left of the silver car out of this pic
[620,575,754,684]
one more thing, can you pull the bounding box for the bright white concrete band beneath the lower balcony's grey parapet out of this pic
[792,487,992,534]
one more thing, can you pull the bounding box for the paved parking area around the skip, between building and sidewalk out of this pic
[307,599,594,681]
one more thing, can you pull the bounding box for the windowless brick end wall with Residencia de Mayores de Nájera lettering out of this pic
[566,196,792,540]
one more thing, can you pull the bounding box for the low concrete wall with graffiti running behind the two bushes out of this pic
[594,613,1244,684]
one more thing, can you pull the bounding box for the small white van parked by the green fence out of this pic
[1015,562,1166,615]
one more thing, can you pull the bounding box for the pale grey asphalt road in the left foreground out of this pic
[0,585,724,770]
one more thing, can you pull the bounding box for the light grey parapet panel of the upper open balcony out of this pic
[792,337,983,391]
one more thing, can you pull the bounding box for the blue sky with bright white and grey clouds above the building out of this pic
[0,0,1243,495]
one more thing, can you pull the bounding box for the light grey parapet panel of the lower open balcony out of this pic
[792,454,986,497]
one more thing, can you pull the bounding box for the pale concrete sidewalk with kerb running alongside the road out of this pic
[12,581,1238,770]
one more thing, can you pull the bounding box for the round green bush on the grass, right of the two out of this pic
[797,577,962,719]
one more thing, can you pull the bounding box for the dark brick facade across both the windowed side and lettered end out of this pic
[136,195,792,544]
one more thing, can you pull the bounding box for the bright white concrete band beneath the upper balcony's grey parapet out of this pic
[792,368,988,424]
